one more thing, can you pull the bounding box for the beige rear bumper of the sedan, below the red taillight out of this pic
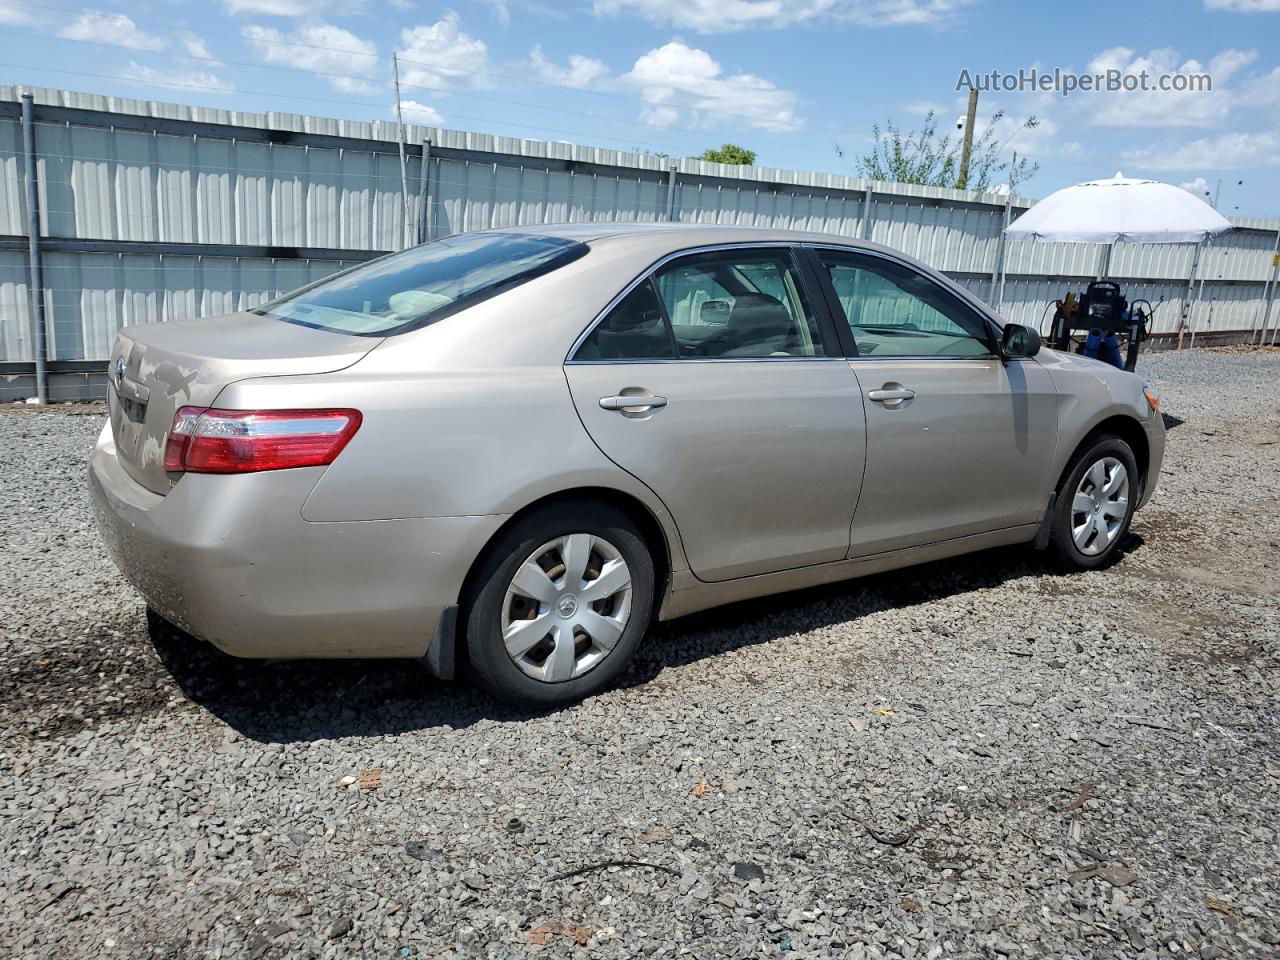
[90,429,506,658]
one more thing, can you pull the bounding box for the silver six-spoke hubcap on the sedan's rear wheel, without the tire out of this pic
[502,534,631,684]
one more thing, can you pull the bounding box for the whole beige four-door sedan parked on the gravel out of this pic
[90,224,1165,703]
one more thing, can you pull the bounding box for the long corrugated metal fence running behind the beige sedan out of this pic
[0,86,1280,399]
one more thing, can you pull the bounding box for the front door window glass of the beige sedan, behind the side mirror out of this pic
[818,251,992,357]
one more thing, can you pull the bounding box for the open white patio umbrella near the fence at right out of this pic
[1001,173,1231,344]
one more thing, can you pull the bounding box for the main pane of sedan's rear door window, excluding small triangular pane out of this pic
[657,248,824,358]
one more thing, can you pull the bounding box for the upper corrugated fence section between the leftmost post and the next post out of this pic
[27,123,420,250]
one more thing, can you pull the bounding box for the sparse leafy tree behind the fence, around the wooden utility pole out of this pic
[836,110,1039,191]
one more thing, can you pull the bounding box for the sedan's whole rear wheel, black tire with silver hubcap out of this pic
[463,502,654,707]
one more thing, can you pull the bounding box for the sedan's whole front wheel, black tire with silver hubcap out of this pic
[1050,434,1140,571]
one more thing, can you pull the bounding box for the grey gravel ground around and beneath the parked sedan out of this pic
[0,351,1280,960]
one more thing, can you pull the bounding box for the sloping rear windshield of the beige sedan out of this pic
[253,233,586,337]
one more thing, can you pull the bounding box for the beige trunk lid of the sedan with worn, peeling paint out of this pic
[106,312,381,493]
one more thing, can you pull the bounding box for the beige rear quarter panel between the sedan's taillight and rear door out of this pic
[218,351,685,570]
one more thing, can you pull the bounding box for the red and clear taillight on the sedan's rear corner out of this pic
[164,407,361,474]
